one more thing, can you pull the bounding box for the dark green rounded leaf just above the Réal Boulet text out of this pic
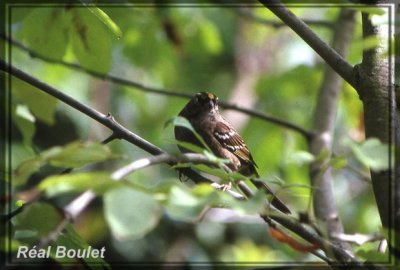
[15,202,63,241]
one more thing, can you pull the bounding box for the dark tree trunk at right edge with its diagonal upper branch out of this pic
[259,0,400,260]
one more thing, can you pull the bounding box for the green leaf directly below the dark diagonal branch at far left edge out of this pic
[11,77,57,125]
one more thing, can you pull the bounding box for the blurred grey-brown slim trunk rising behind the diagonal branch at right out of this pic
[310,9,355,253]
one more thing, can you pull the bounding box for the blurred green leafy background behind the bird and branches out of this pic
[4,3,387,264]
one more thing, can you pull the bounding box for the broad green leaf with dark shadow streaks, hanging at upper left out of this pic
[70,8,111,73]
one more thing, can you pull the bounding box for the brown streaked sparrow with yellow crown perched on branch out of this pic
[174,92,291,214]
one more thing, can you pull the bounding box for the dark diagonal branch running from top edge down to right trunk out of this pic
[259,0,356,88]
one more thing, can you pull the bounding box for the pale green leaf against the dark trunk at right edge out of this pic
[345,138,389,172]
